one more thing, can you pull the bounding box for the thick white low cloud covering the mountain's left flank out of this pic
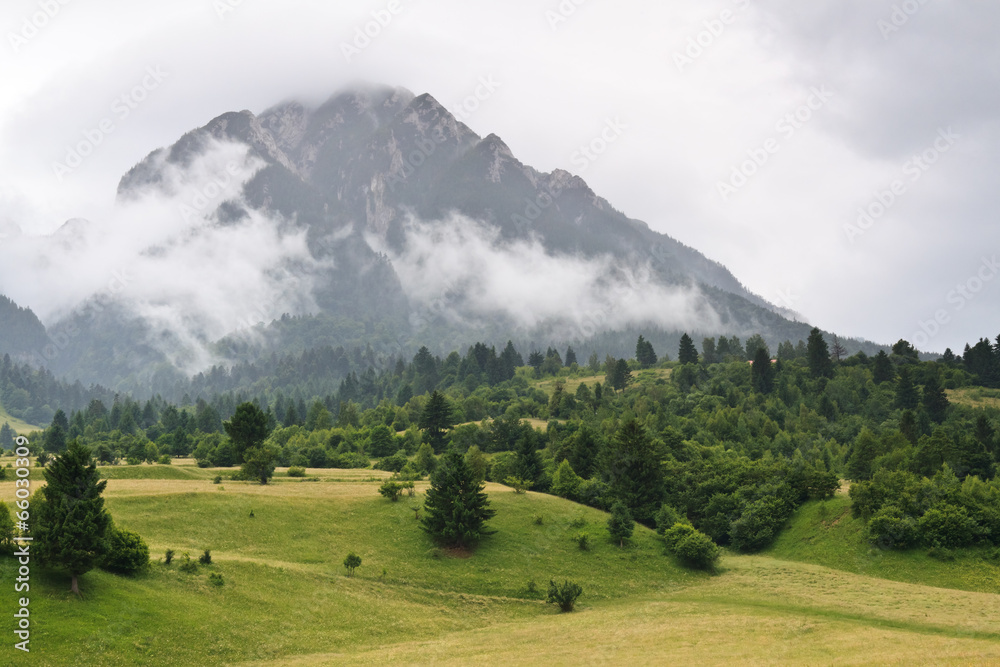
[0,142,318,372]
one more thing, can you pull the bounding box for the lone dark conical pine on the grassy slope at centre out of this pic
[421,449,496,549]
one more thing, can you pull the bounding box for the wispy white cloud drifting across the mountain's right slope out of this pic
[368,214,720,339]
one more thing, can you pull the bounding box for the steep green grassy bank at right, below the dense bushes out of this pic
[767,495,1000,593]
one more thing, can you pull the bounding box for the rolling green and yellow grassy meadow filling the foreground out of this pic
[0,461,1000,665]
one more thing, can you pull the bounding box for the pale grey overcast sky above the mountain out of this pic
[0,0,1000,351]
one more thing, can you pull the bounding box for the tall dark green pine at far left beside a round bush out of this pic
[32,440,111,595]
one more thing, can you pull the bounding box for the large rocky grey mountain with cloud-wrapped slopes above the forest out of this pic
[37,86,850,396]
